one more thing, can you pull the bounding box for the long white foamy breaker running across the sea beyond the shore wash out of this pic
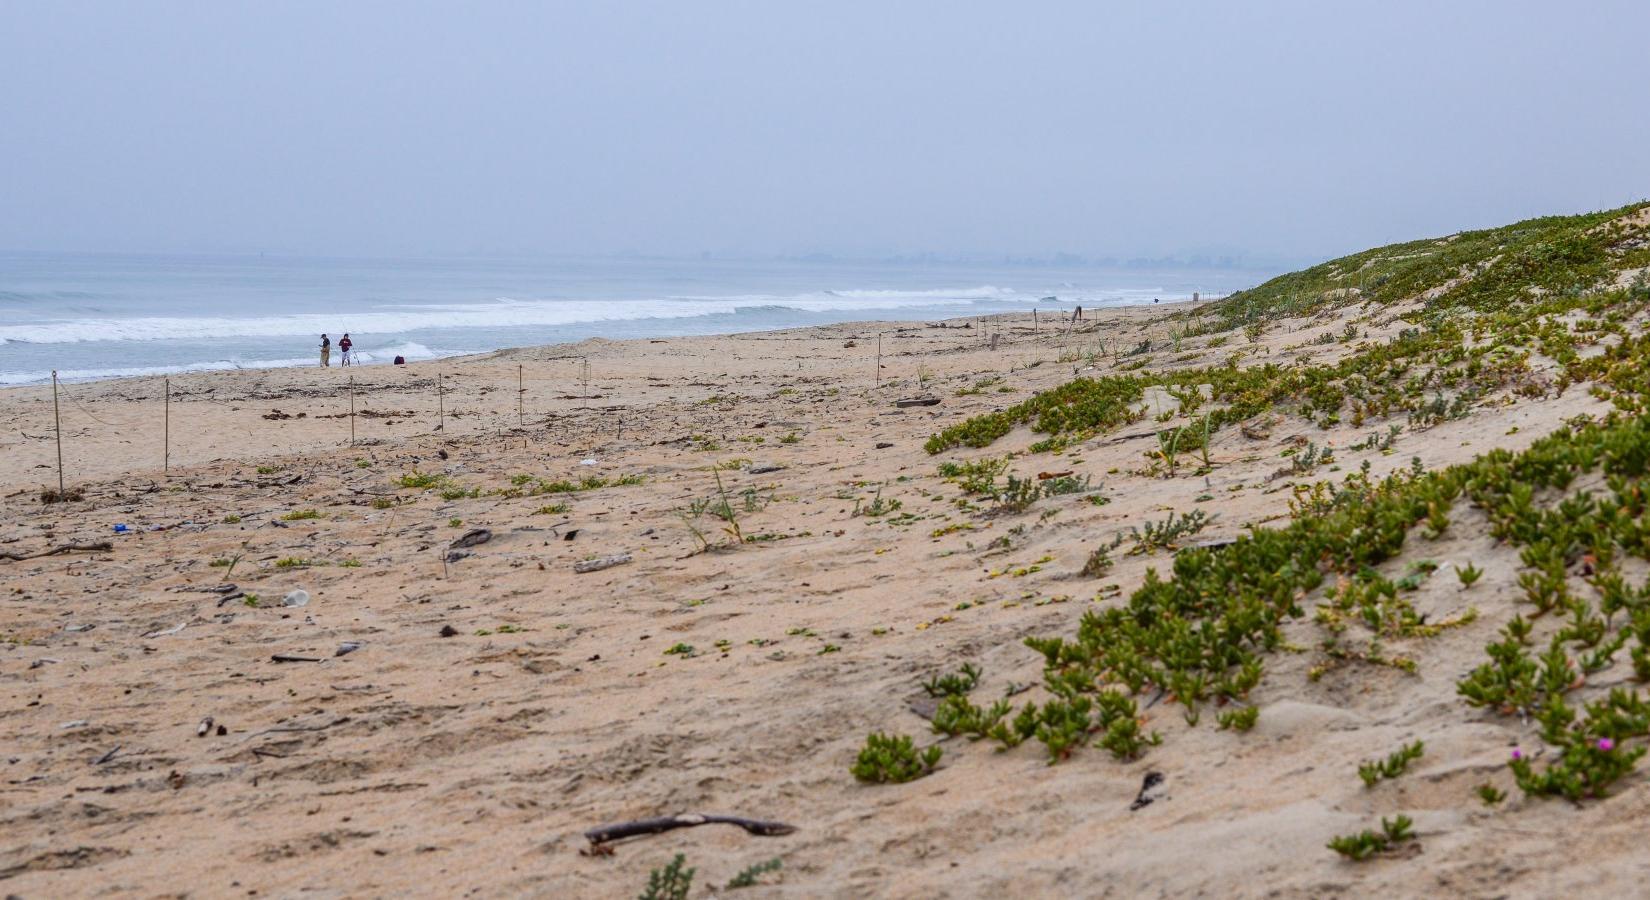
[0,286,1170,345]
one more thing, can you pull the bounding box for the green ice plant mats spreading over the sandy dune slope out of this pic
[891,205,1650,832]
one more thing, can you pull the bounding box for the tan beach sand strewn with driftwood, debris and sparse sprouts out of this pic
[0,306,1623,897]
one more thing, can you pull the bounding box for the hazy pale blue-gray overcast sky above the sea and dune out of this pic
[0,0,1650,258]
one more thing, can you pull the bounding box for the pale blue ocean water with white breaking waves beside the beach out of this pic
[0,254,1269,385]
